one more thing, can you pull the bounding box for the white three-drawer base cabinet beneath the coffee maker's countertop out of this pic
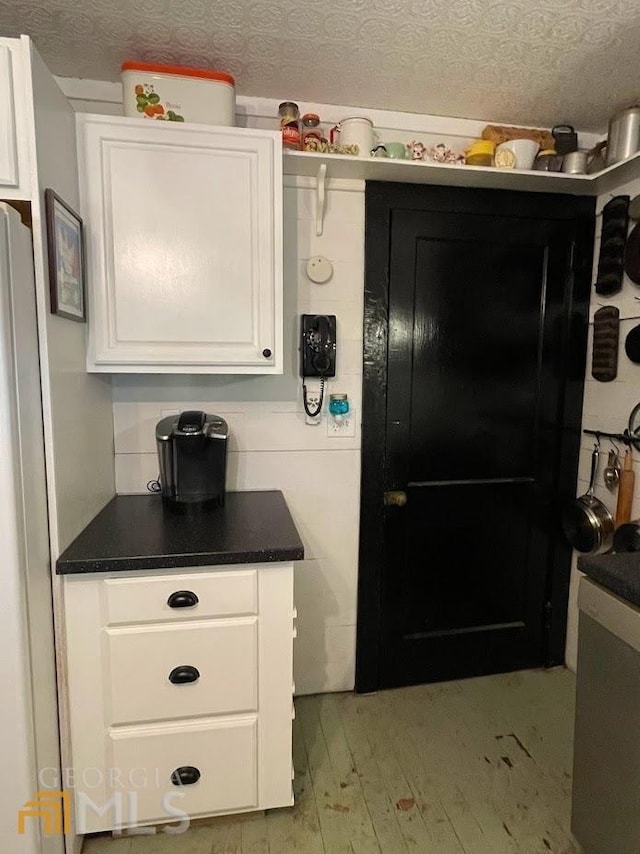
[63,563,294,832]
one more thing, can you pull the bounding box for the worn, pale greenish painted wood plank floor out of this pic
[83,668,581,854]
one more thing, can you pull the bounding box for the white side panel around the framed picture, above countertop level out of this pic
[31,46,114,560]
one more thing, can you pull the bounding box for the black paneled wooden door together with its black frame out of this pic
[358,185,593,690]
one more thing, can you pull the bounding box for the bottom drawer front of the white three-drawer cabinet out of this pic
[109,717,258,824]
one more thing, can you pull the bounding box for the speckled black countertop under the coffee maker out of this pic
[56,490,304,575]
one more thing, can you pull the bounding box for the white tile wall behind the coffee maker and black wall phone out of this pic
[113,181,364,694]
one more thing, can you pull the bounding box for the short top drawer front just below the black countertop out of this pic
[102,569,258,625]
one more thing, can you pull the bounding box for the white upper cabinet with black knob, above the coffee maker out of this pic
[78,115,282,374]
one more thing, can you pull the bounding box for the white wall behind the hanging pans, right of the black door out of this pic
[566,179,640,670]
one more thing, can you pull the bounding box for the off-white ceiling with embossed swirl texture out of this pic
[0,0,640,131]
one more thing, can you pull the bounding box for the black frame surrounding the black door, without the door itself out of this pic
[355,182,596,693]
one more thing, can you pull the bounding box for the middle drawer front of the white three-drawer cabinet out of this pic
[106,617,258,724]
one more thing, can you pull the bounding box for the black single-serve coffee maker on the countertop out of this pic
[156,410,229,505]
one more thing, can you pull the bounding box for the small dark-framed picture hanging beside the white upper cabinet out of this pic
[44,190,87,323]
